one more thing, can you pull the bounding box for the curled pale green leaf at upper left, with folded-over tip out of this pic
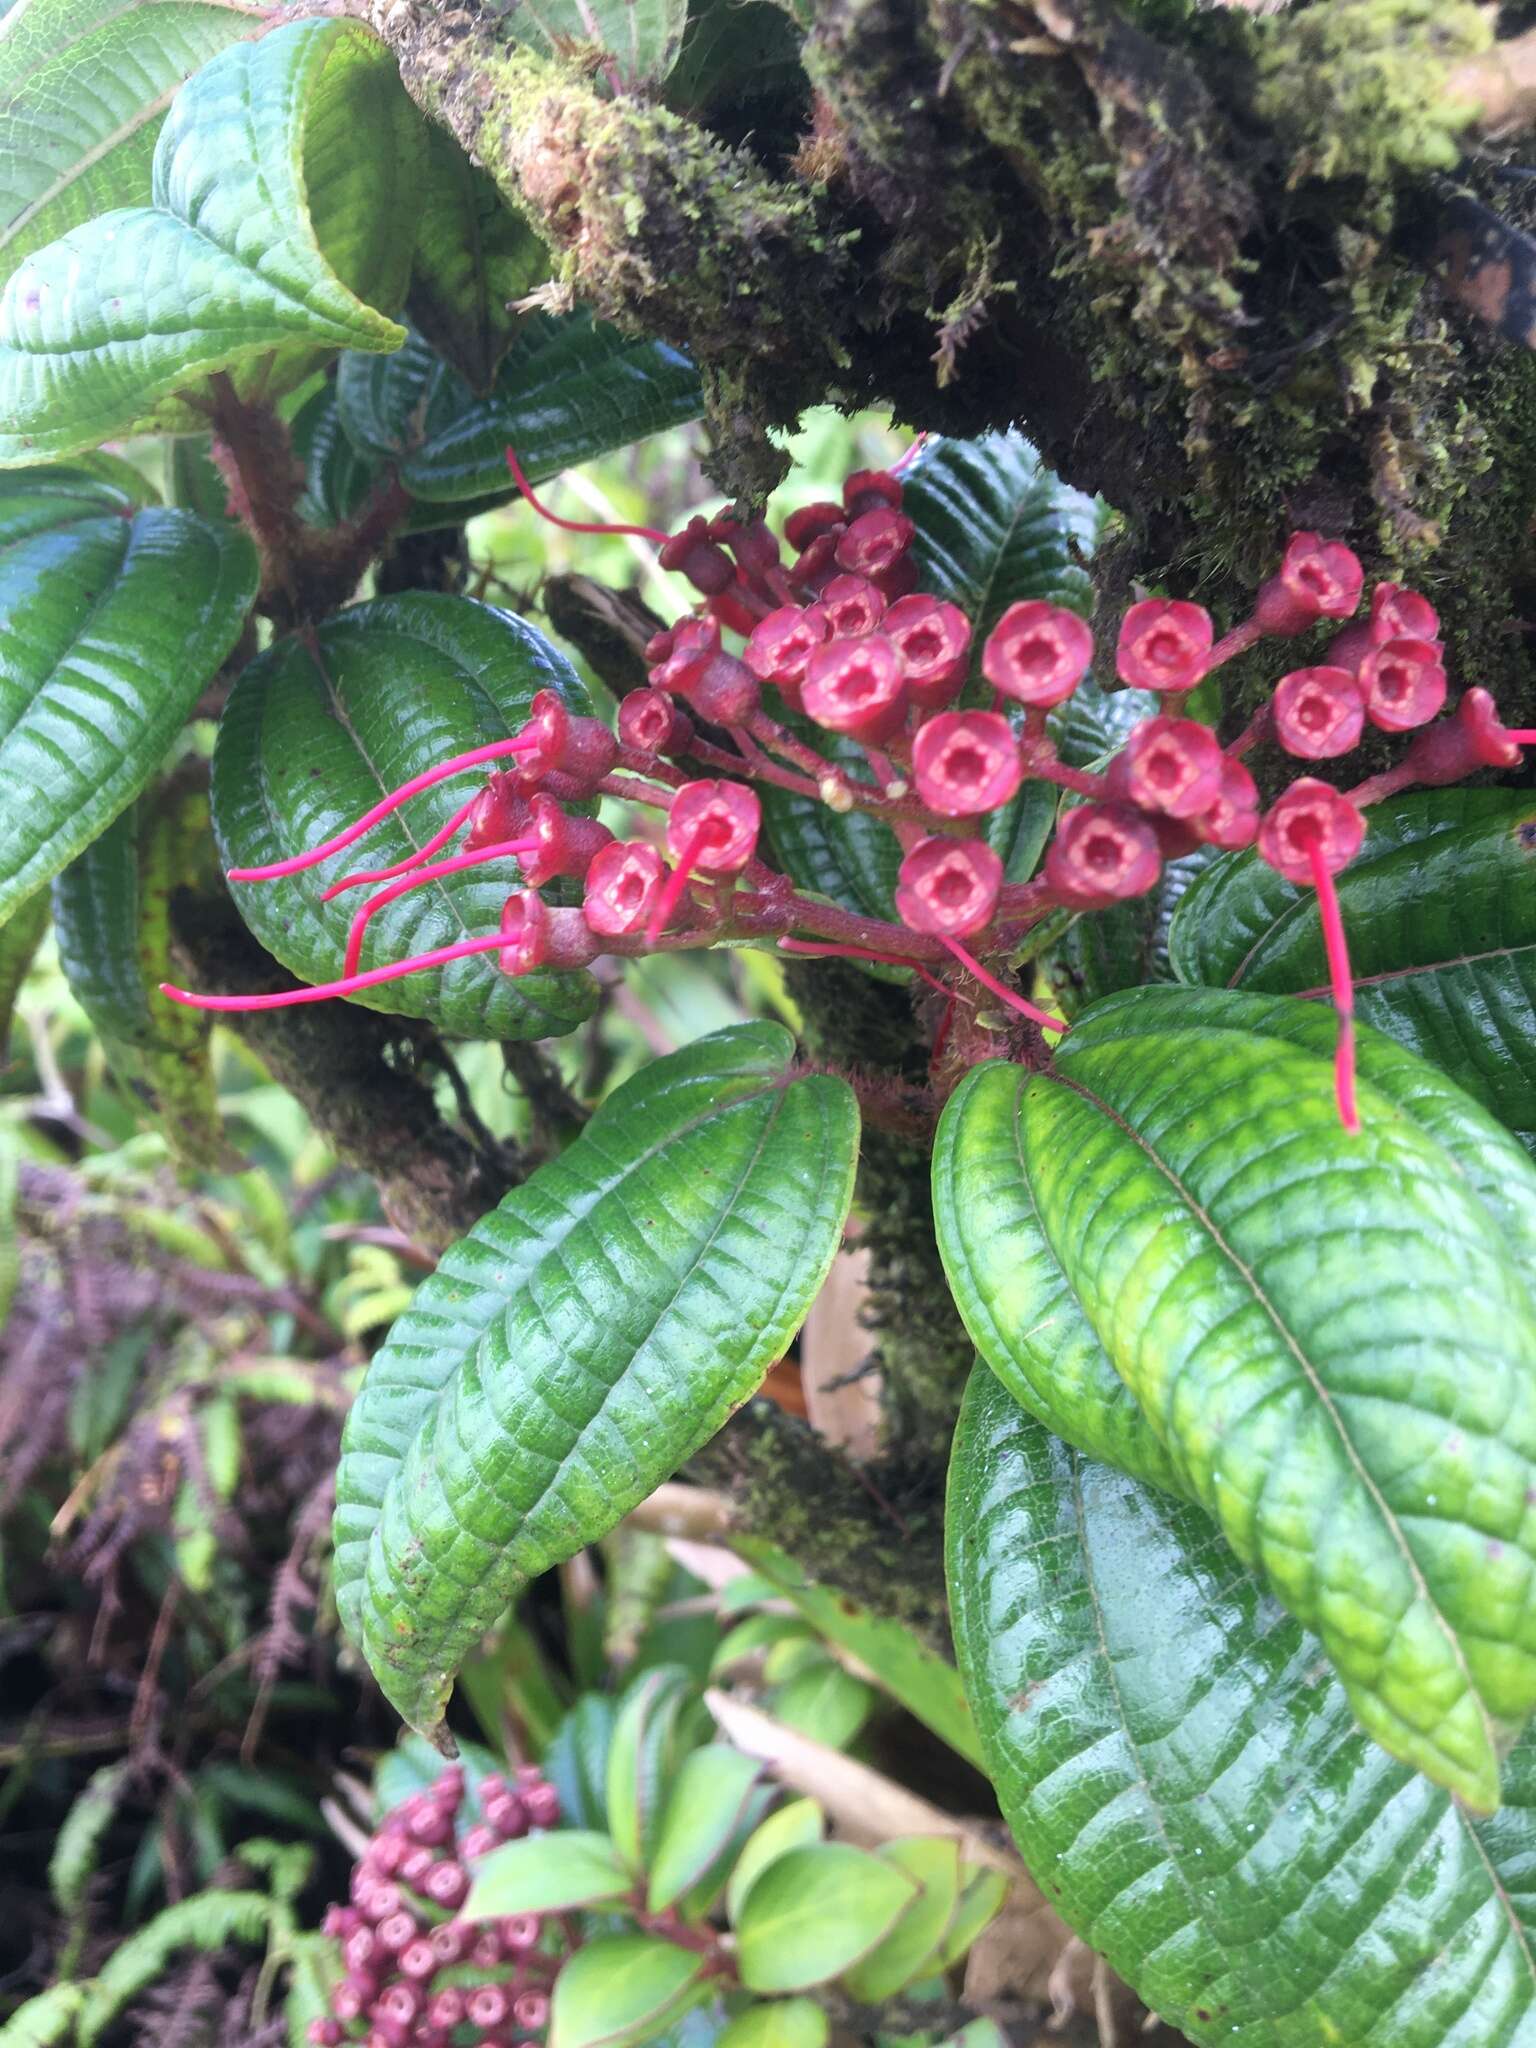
[0,20,422,463]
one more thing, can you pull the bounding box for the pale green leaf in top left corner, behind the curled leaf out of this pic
[0,0,264,283]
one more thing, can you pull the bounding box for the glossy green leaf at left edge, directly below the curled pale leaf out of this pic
[0,471,256,922]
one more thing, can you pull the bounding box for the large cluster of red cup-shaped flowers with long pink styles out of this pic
[166,457,1534,1128]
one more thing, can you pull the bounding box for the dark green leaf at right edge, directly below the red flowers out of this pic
[1169,788,1536,1145]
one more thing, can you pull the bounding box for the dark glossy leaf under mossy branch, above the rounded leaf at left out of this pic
[336,313,702,516]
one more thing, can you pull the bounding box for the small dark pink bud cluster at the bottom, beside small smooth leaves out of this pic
[309,1765,559,2048]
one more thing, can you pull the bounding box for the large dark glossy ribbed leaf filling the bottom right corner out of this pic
[946,1370,1536,2048]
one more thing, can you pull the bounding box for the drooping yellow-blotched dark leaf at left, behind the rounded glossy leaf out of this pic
[53,791,225,1165]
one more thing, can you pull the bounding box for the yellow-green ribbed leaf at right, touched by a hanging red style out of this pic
[1018,987,1536,1810]
